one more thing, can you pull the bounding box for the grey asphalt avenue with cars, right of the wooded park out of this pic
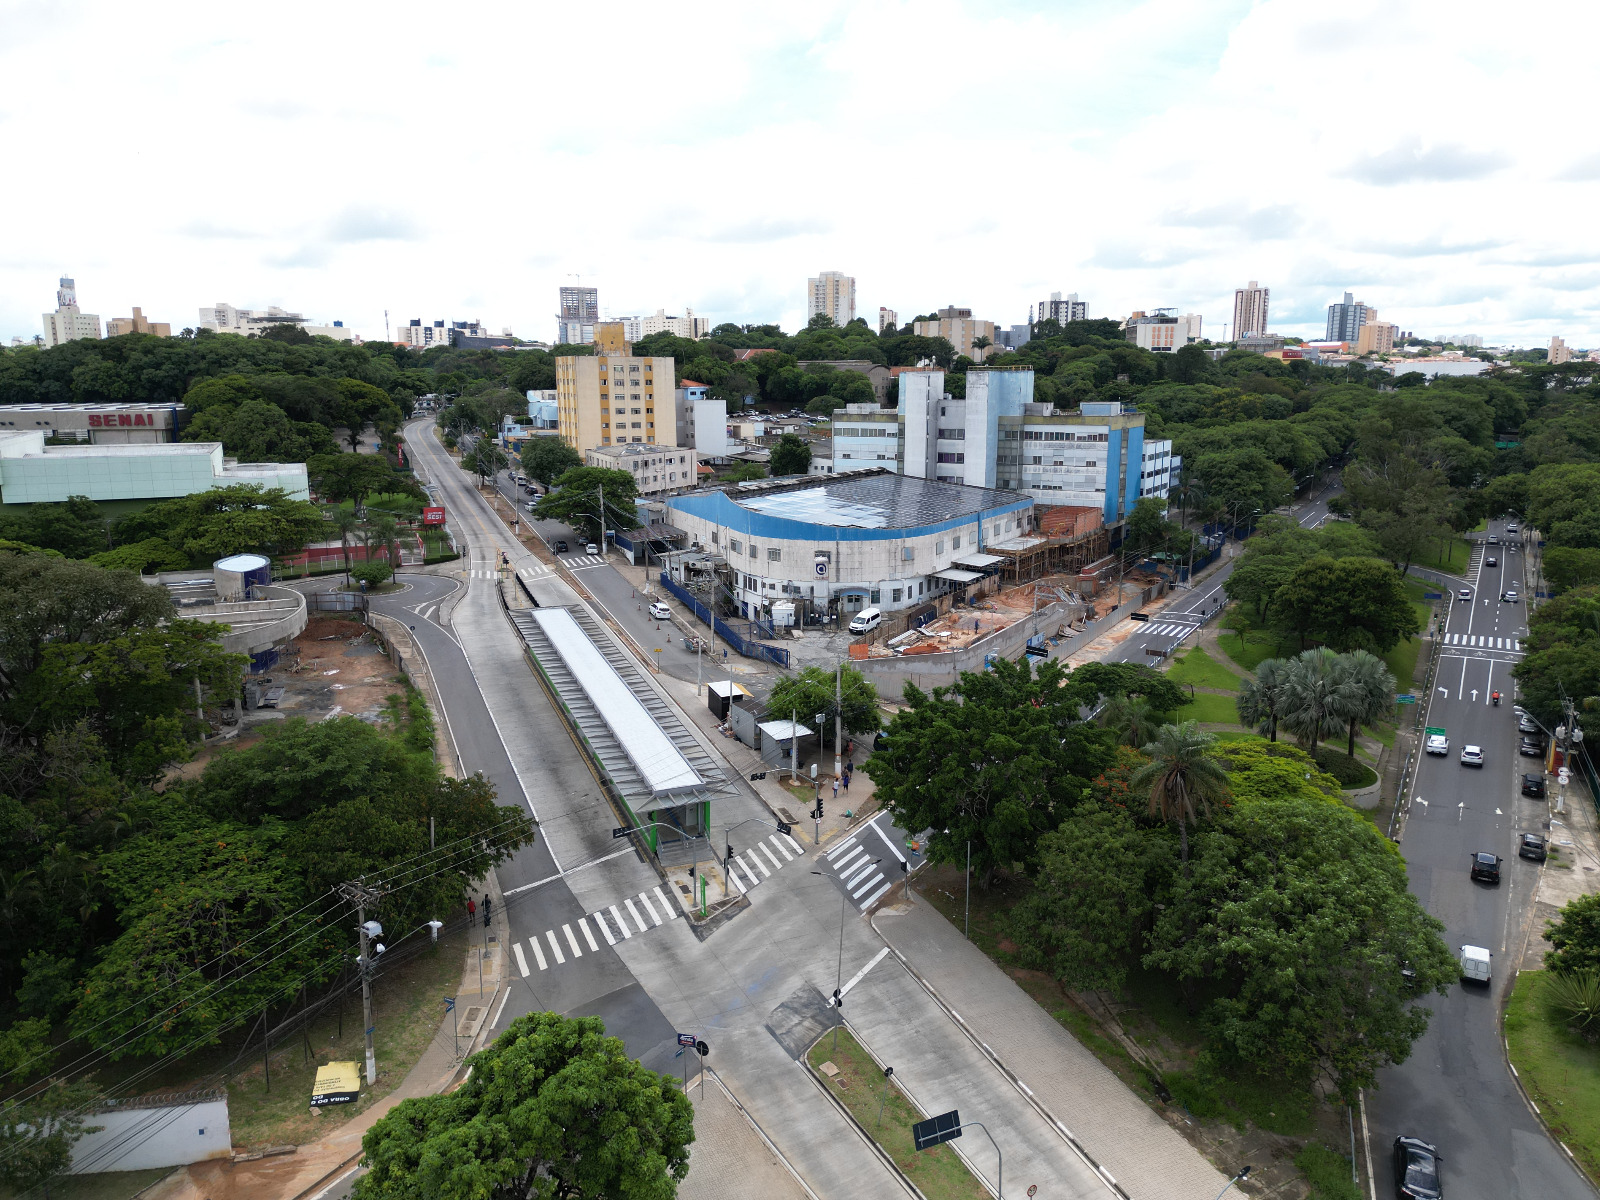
[1366,522,1594,1200]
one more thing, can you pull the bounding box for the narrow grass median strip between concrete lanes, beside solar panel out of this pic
[806,1029,994,1200]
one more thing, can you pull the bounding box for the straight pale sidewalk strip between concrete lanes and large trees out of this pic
[872,893,1227,1200]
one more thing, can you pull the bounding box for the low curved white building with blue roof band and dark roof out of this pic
[666,470,1034,618]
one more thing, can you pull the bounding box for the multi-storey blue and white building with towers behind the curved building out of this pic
[834,368,1181,525]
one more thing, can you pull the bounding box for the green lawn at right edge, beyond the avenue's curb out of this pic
[1506,971,1600,1178]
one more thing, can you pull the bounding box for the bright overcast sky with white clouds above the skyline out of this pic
[0,0,1600,346]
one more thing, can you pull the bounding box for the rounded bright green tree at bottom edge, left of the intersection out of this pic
[352,1013,694,1200]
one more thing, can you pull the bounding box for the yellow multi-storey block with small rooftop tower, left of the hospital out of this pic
[555,334,677,451]
